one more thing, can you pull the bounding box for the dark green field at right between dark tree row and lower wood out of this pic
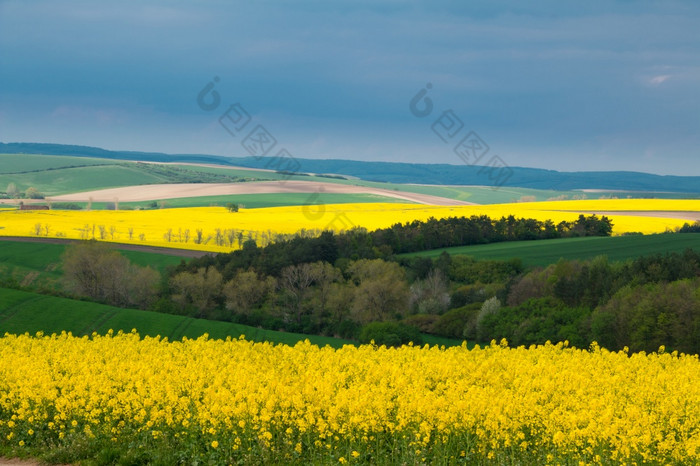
[402,233,700,266]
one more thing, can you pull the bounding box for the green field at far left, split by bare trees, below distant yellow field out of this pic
[0,241,181,289]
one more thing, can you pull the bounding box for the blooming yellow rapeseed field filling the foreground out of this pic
[0,333,700,464]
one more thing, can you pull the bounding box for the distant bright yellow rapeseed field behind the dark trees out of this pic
[0,199,700,251]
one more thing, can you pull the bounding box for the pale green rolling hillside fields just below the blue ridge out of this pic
[5,154,697,208]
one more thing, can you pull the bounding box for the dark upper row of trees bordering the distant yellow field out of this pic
[176,215,613,279]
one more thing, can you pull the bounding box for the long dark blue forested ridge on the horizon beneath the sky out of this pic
[0,143,700,193]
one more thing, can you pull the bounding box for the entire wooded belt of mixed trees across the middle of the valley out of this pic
[24,212,700,353]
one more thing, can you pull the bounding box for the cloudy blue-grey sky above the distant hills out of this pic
[0,0,700,175]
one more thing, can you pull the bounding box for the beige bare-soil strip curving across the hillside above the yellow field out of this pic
[47,181,474,206]
